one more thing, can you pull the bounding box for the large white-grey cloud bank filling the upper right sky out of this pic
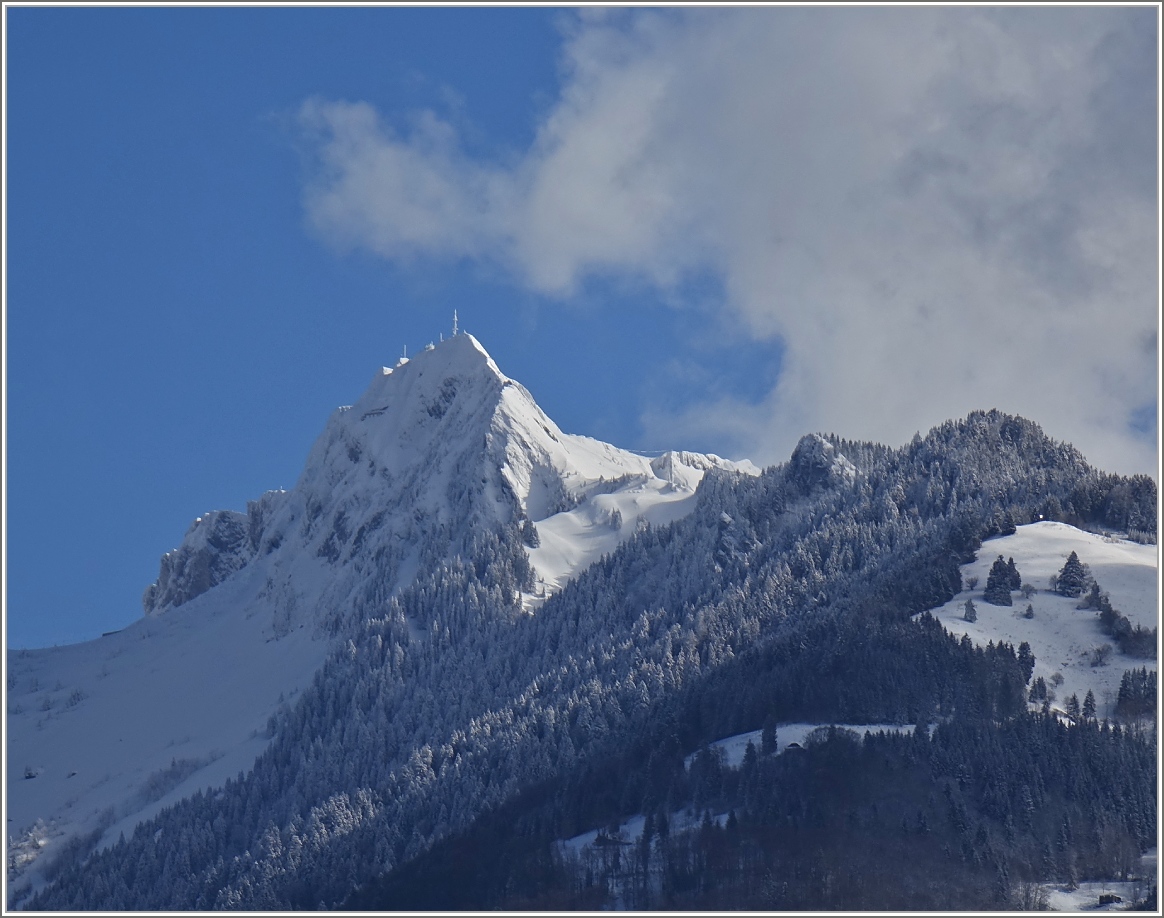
[303,7,1159,471]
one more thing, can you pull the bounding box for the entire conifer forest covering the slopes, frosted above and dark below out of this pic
[22,412,1158,910]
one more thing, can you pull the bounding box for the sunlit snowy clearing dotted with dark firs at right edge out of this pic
[934,522,1159,718]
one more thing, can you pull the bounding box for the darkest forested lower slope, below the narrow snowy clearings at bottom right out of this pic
[346,713,1156,910]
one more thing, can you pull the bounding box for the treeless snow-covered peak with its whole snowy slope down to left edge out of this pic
[6,334,757,902]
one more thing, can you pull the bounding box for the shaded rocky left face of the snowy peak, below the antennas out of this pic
[143,335,523,619]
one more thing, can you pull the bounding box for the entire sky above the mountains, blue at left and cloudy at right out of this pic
[5,7,1159,647]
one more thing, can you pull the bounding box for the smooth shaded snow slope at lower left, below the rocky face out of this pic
[5,565,326,902]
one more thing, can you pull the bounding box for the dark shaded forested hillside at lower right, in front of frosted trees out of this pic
[346,563,1156,910]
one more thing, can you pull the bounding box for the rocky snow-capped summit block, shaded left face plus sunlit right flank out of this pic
[143,334,755,634]
